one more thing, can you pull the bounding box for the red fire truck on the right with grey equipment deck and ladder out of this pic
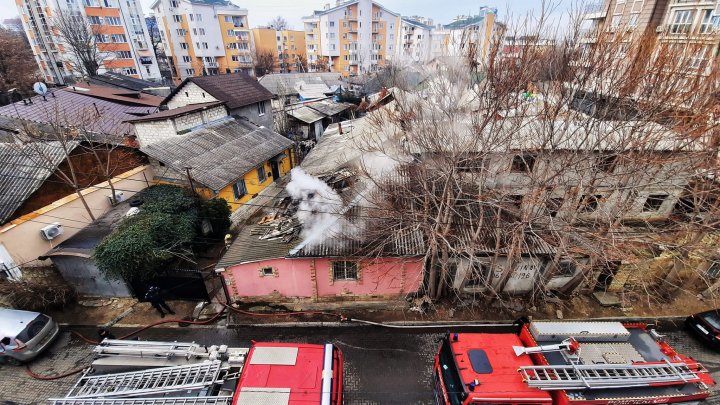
[433,322,715,405]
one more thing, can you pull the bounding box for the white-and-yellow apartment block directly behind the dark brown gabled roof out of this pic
[150,0,254,80]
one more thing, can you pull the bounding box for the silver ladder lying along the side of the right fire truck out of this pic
[518,360,707,390]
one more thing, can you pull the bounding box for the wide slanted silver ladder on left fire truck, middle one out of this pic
[66,361,226,398]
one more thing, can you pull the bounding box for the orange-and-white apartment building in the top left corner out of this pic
[16,0,161,84]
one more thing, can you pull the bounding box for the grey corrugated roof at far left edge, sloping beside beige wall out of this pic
[0,142,78,224]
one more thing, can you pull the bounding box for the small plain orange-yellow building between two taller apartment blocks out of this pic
[252,27,307,73]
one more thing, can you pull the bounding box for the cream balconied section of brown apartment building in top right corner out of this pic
[657,0,720,74]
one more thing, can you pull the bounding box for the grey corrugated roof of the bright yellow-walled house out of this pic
[141,119,293,191]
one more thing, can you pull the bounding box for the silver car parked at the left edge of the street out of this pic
[0,308,60,364]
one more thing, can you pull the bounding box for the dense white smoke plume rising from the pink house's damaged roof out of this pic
[285,167,345,246]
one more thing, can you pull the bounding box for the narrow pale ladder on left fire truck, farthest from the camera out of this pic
[93,339,207,358]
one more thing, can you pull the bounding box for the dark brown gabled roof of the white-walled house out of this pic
[165,73,273,110]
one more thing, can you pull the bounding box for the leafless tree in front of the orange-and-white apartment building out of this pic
[53,12,115,76]
